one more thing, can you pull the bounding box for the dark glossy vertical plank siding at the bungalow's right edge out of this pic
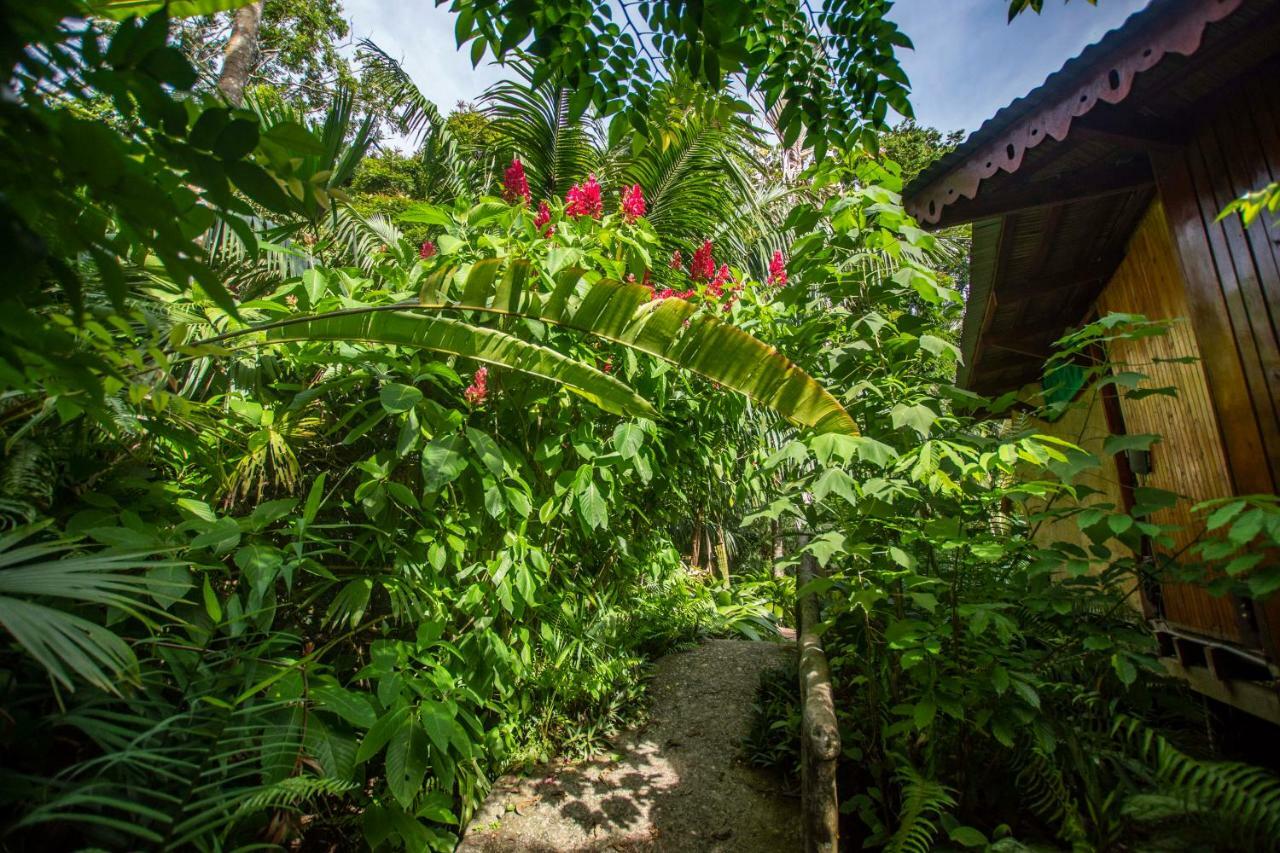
[1152,74,1280,660]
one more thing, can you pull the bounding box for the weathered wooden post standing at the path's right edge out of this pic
[796,534,840,853]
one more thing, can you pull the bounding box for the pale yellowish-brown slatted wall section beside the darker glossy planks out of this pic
[1097,201,1252,643]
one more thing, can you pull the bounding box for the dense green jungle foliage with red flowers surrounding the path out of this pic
[0,0,1280,850]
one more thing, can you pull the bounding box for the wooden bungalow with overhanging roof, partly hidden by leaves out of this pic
[906,0,1280,722]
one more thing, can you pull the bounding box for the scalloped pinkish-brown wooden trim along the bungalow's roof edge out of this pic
[906,0,1243,224]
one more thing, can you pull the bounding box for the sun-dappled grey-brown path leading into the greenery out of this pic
[458,640,800,853]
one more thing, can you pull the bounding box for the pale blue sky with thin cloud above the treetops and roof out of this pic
[343,0,1147,142]
